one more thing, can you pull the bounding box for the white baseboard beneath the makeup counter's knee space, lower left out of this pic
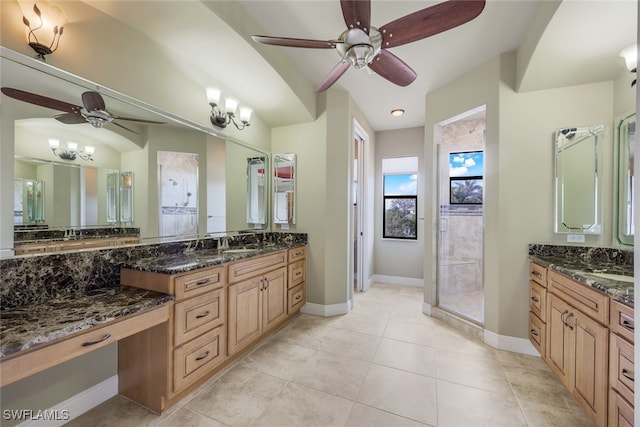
[18,375,118,427]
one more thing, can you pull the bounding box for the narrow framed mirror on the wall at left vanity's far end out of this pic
[273,153,296,229]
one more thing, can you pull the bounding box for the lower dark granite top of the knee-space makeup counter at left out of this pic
[0,286,173,357]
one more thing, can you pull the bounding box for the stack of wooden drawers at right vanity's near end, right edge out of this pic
[609,301,635,427]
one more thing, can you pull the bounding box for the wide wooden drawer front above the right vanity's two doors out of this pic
[548,271,609,324]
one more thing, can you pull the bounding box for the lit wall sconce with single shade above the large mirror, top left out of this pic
[22,3,67,61]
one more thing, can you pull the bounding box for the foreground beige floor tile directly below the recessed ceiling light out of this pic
[356,364,436,425]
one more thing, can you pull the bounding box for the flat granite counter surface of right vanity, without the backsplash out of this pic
[529,254,634,307]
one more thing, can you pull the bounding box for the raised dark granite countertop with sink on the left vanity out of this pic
[123,242,302,274]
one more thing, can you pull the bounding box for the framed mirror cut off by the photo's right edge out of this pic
[615,113,636,246]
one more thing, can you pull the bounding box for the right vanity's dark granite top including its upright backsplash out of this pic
[529,245,634,306]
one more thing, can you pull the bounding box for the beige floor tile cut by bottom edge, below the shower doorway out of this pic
[437,380,527,427]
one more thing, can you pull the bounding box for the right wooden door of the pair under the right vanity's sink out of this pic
[565,308,609,426]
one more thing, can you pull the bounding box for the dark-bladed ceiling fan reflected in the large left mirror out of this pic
[0,87,164,134]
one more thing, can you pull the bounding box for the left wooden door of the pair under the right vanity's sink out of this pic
[546,295,573,389]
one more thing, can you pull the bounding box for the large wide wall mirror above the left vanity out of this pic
[0,48,270,255]
